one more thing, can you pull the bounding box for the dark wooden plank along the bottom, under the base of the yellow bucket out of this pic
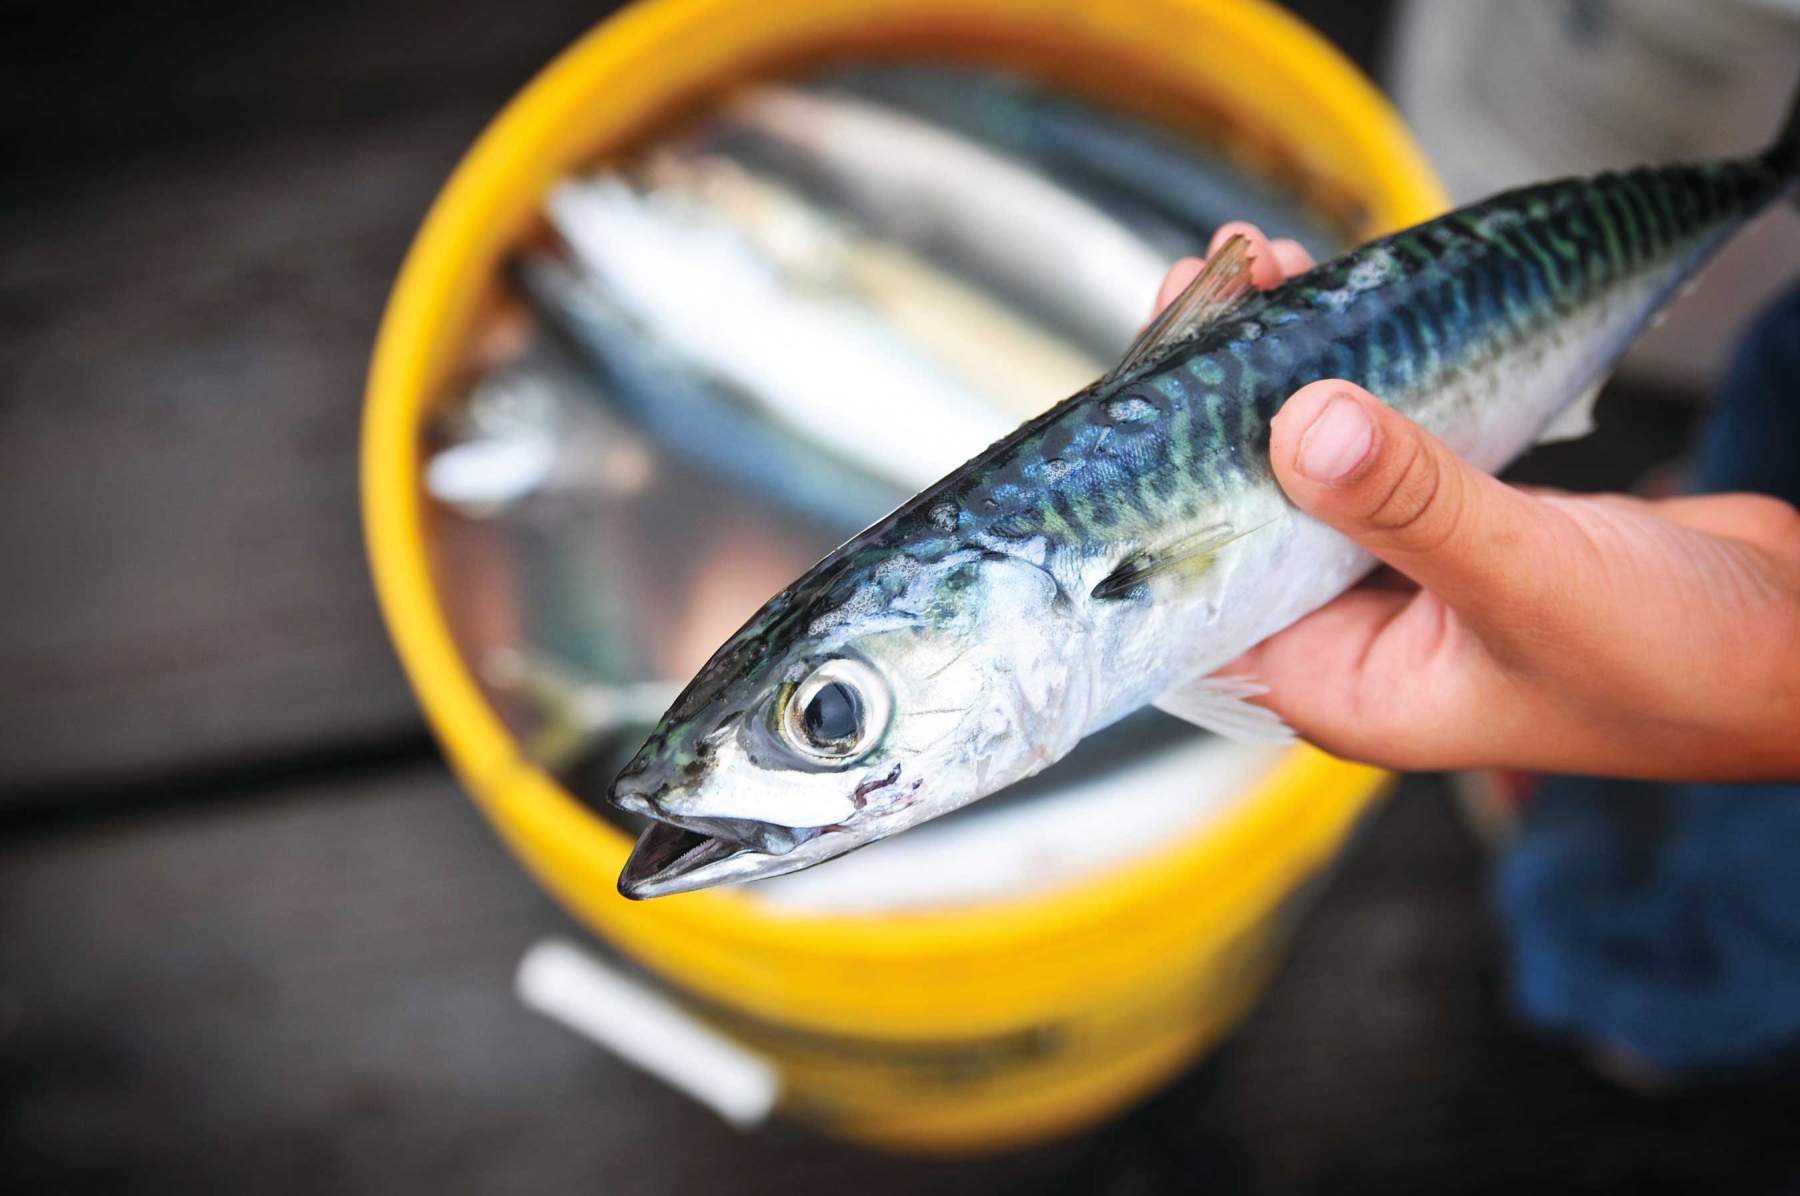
[0,769,1800,1196]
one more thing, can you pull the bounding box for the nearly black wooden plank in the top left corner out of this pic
[0,0,619,175]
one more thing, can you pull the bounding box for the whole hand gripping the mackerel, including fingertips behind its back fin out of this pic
[1156,223,1800,780]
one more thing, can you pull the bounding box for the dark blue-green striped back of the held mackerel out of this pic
[914,154,1778,548]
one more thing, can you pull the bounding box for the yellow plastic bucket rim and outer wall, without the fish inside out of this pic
[362,0,1444,1149]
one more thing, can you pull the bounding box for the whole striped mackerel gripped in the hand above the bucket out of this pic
[612,93,1800,897]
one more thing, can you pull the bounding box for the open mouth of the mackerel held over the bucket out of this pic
[619,818,851,901]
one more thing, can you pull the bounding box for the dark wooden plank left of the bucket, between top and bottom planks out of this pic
[0,113,457,789]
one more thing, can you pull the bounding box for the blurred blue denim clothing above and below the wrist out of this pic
[1496,277,1800,1077]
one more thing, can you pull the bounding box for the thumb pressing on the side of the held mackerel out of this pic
[1269,380,1555,621]
